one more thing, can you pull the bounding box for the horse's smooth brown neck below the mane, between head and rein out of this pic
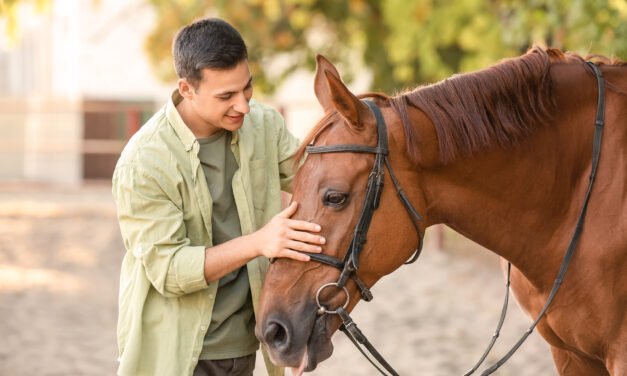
[402,81,595,289]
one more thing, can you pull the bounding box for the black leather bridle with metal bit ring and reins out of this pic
[302,62,605,376]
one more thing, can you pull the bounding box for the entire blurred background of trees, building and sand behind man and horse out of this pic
[0,0,627,375]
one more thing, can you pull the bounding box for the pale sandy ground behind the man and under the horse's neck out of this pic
[0,184,557,376]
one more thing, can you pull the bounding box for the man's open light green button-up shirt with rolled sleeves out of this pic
[113,91,298,376]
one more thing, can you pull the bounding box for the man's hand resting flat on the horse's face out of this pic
[251,202,326,261]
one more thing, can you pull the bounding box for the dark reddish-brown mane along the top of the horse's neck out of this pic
[390,47,572,163]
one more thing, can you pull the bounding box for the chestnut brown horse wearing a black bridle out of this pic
[256,48,627,376]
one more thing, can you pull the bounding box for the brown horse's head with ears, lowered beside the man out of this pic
[256,56,426,371]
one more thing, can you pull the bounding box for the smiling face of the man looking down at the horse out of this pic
[182,60,253,134]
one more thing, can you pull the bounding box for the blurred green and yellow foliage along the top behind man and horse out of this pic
[147,0,627,93]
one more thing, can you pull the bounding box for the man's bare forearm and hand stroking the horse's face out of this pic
[205,202,325,283]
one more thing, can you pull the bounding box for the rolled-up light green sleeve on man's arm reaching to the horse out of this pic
[113,165,207,297]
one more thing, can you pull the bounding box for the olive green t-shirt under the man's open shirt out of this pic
[198,130,259,360]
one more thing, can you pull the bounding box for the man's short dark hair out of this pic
[172,18,248,86]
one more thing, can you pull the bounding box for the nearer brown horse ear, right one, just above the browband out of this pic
[325,71,376,129]
